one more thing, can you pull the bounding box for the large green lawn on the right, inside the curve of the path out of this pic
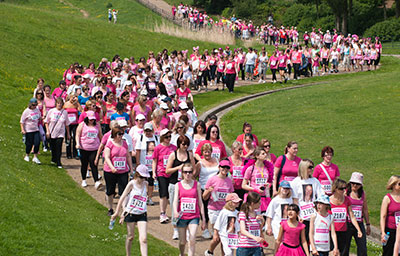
[221,57,400,226]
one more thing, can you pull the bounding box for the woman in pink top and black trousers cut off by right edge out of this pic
[380,175,400,256]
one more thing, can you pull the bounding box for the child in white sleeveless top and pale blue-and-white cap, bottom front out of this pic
[310,195,339,256]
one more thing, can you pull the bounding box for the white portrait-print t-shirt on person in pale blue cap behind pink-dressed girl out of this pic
[266,196,293,239]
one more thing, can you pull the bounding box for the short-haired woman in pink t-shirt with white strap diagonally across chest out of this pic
[313,146,340,195]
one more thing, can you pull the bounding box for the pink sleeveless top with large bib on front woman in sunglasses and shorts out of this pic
[178,181,201,220]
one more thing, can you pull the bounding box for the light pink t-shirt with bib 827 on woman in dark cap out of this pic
[204,175,233,211]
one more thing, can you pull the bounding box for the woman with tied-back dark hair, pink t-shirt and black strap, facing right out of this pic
[273,141,301,195]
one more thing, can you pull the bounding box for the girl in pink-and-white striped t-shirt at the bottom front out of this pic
[236,192,264,256]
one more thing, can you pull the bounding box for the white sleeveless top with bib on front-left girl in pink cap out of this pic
[125,182,147,215]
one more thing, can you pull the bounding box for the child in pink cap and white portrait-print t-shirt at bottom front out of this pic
[204,193,242,256]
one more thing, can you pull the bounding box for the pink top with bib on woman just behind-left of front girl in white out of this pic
[104,140,129,174]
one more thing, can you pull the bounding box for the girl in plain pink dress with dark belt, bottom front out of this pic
[275,204,310,256]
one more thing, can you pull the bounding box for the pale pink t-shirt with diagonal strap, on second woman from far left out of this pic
[45,108,69,139]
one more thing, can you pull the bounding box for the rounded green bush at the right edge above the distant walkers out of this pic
[364,18,400,41]
